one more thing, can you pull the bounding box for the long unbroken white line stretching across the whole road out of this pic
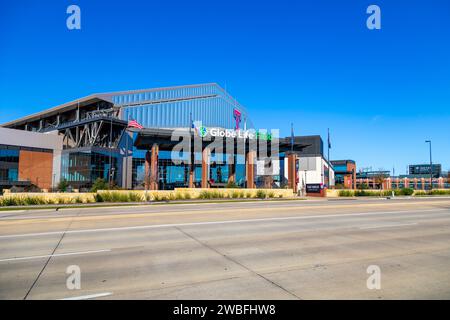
[0,209,449,239]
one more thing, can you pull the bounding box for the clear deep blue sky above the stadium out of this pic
[0,0,450,173]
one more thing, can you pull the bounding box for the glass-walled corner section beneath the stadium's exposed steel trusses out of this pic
[61,150,120,188]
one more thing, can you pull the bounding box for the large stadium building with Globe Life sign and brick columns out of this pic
[0,83,334,190]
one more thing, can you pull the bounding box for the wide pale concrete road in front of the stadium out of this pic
[0,199,450,299]
